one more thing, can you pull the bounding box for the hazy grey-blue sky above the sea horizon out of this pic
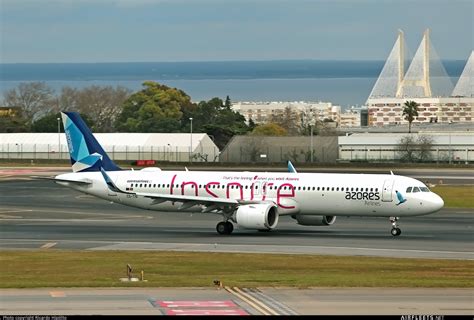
[0,0,474,63]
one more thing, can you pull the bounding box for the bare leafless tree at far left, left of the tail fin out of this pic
[3,82,57,125]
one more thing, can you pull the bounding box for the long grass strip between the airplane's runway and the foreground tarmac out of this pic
[0,250,474,288]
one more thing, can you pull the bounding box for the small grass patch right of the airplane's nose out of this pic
[431,185,474,208]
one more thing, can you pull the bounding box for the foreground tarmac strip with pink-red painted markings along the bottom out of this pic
[0,288,474,320]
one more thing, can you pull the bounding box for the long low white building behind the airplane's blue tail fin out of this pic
[0,133,219,162]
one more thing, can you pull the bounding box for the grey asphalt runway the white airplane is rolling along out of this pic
[0,180,474,259]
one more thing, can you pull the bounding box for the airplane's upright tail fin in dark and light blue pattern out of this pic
[61,112,122,172]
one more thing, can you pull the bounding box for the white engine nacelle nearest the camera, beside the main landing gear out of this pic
[235,203,278,230]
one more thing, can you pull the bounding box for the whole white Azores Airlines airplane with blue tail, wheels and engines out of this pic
[53,112,444,236]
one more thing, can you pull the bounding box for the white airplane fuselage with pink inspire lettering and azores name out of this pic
[57,168,443,217]
